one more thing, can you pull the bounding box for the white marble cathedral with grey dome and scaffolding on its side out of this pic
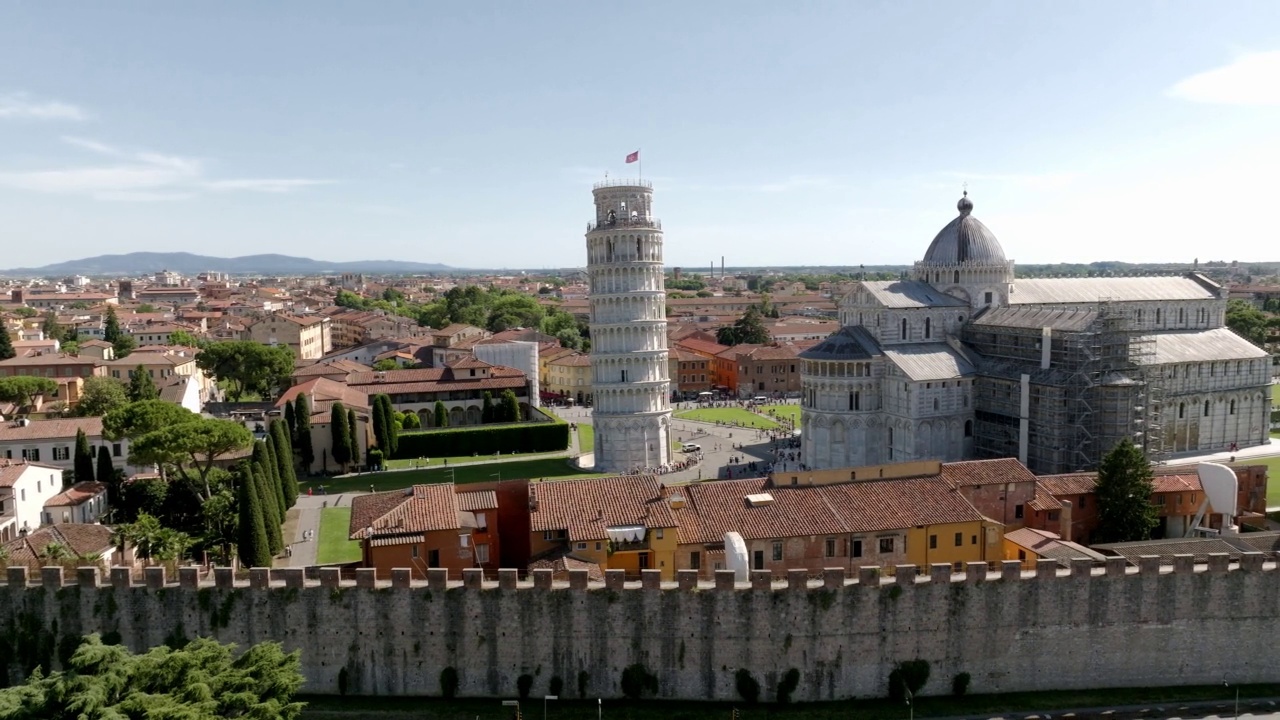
[801,192,1271,474]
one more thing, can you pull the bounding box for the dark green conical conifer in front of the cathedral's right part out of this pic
[1093,438,1160,542]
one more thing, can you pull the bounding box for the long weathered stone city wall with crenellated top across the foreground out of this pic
[0,553,1280,701]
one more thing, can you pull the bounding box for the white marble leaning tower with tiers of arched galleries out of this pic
[586,181,671,473]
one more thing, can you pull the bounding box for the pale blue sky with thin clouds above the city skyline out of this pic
[0,0,1280,269]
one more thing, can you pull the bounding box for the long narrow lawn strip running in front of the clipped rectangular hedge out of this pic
[302,457,605,495]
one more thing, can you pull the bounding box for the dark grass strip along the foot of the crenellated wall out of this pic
[298,678,1280,720]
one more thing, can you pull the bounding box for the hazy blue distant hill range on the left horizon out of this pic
[0,252,453,277]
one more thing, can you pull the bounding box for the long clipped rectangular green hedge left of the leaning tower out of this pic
[393,423,568,460]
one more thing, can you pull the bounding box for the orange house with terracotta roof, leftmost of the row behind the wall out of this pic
[349,483,498,578]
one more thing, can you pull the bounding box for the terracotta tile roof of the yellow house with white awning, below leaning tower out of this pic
[529,475,676,542]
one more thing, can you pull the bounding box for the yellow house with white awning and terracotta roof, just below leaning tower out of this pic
[529,475,680,580]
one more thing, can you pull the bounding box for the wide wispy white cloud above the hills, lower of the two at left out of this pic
[0,136,332,202]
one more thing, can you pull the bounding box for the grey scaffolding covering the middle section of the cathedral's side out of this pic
[964,299,1164,474]
